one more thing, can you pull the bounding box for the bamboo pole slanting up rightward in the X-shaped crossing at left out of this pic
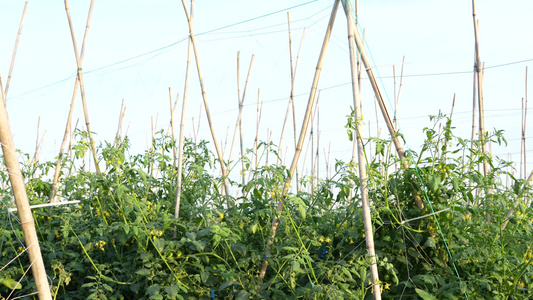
[50,0,94,203]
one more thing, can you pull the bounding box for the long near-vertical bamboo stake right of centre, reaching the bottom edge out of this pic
[342,1,381,300]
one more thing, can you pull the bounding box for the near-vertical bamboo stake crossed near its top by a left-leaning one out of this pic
[174,0,193,218]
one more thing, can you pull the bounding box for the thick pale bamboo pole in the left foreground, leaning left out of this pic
[0,78,52,300]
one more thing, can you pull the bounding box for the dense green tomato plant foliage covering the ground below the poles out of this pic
[0,114,533,299]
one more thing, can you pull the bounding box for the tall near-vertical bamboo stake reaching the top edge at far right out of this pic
[472,0,490,176]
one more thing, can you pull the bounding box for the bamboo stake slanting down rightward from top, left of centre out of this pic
[181,0,230,202]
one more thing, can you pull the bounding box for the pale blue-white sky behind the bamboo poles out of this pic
[0,0,533,178]
